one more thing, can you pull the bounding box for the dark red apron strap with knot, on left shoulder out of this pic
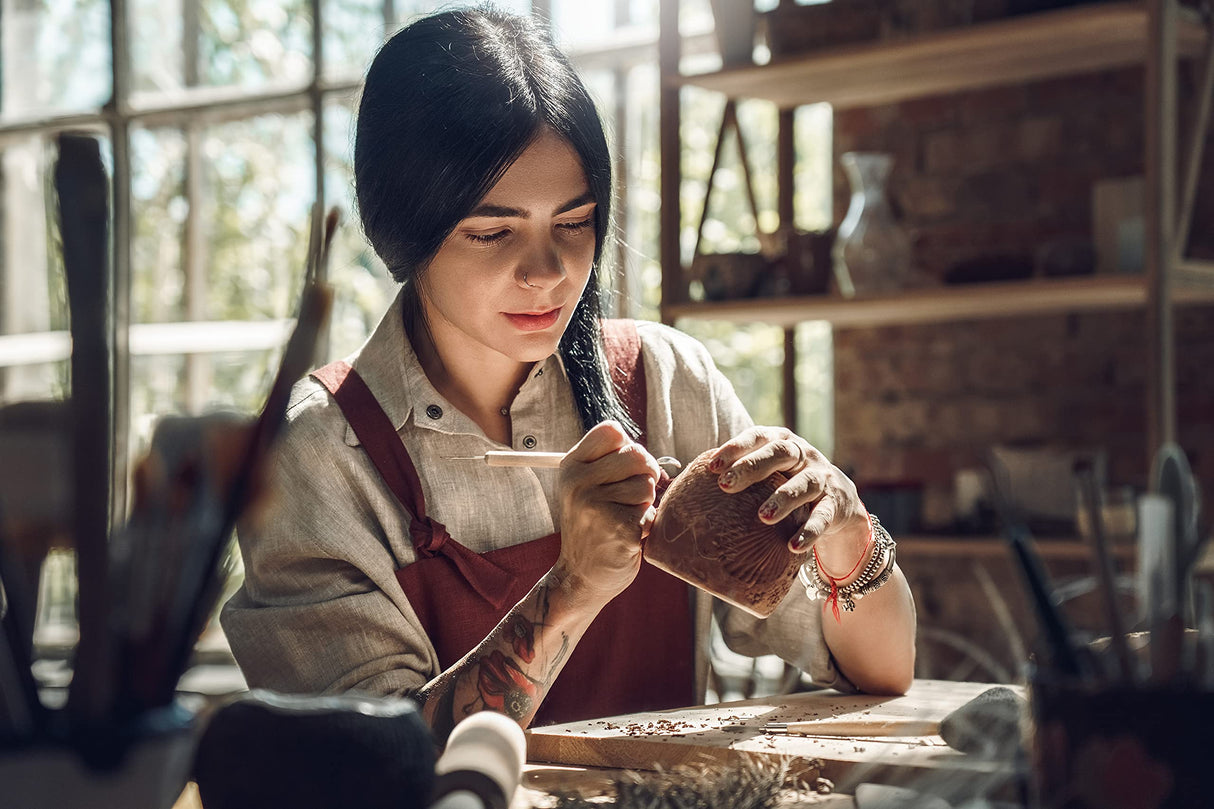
[312,360,514,609]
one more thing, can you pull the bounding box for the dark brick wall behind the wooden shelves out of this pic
[834,68,1214,524]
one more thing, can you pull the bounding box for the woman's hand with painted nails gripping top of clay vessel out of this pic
[709,426,869,553]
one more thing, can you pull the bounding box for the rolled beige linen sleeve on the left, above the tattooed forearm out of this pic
[221,383,437,696]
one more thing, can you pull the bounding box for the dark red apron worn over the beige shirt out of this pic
[312,321,696,726]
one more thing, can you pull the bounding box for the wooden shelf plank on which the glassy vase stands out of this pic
[662,276,1214,328]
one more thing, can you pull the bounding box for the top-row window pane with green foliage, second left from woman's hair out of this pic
[198,0,312,87]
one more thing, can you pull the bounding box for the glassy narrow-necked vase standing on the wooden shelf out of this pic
[833,152,913,298]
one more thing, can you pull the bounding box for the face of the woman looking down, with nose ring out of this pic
[419,129,595,363]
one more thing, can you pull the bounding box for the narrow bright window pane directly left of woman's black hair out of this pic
[324,101,399,358]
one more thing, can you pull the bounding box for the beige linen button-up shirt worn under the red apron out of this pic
[221,295,852,698]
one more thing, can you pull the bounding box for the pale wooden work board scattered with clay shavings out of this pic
[174,680,1019,809]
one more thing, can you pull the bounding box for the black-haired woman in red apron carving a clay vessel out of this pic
[223,10,914,736]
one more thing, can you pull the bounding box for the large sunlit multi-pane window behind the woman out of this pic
[0,0,830,685]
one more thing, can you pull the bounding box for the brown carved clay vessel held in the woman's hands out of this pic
[645,449,805,618]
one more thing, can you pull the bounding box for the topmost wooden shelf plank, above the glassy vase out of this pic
[674,1,1206,108]
